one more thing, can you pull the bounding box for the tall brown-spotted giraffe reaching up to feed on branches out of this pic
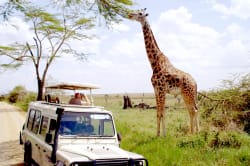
[128,8,199,136]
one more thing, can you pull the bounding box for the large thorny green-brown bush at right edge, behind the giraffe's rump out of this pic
[199,73,250,133]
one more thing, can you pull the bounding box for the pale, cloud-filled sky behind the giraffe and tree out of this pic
[0,0,250,93]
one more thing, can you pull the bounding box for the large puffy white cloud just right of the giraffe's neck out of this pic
[153,7,220,67]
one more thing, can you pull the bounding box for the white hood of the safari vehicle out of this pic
[60,144,142,160]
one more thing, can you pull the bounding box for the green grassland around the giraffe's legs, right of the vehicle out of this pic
[95,94,250,166]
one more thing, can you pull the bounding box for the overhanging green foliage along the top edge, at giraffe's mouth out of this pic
[0,0,134,24]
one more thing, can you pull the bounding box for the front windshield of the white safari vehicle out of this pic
[59,112,115,137]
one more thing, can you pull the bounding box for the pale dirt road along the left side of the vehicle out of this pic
[0,102,25,166]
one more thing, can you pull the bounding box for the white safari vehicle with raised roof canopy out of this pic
[20,84,148,166]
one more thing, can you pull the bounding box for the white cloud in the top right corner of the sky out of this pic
[209,0,250,19]
